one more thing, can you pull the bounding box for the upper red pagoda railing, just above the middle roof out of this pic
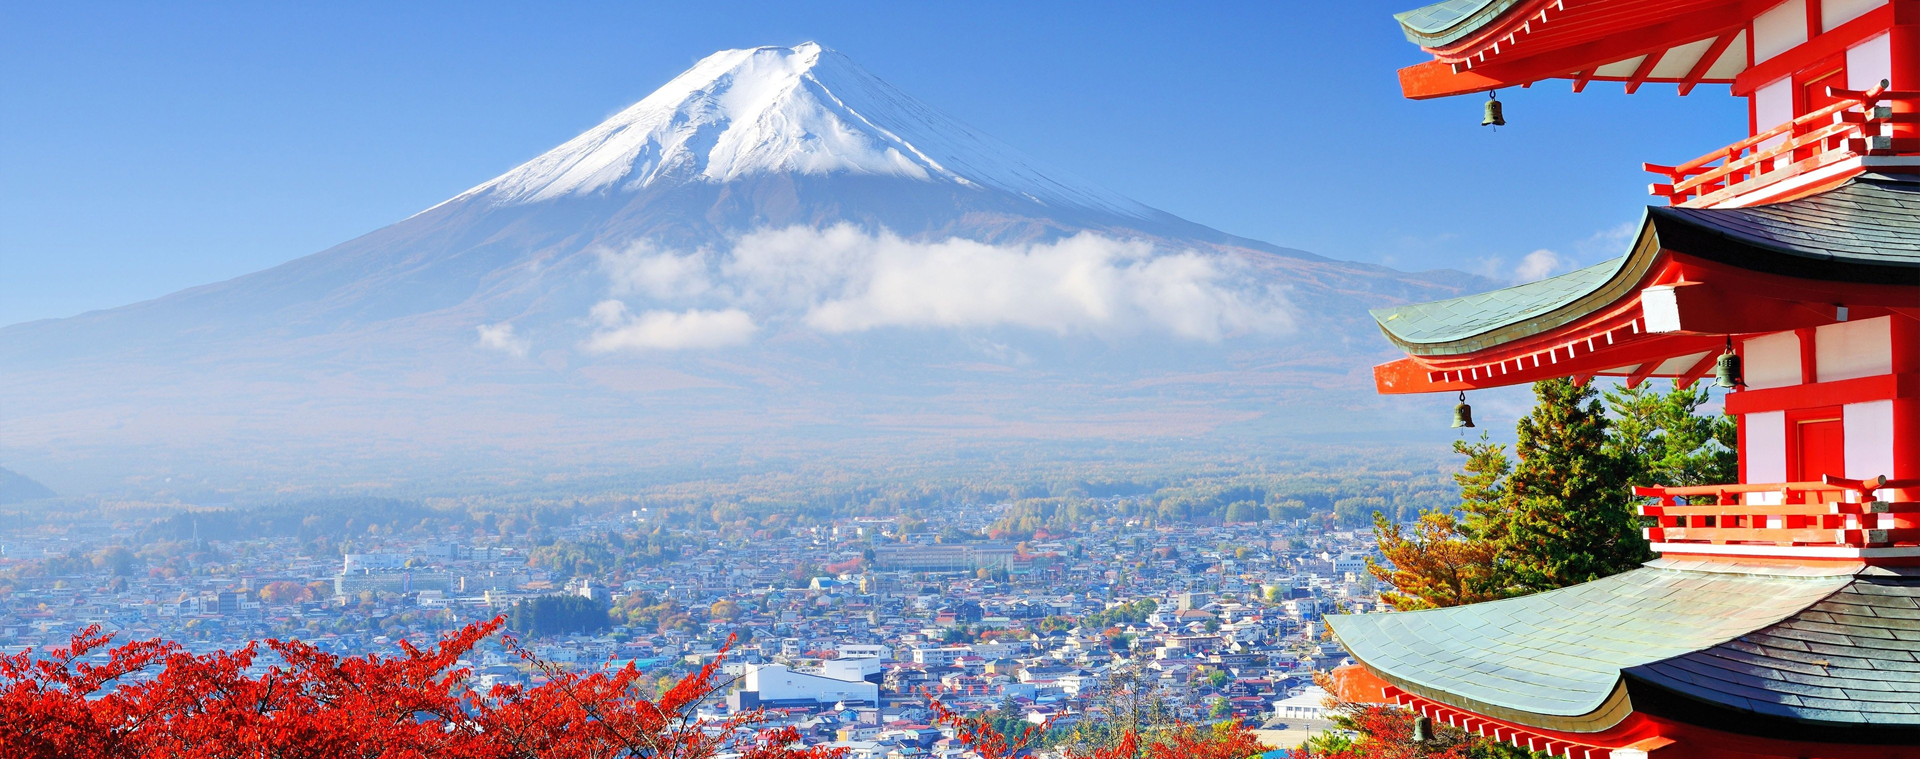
[1642,81,1920,206]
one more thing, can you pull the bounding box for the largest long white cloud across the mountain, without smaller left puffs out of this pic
[722,225,1292,340]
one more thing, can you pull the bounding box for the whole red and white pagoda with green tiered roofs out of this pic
[1329,0,1920,759]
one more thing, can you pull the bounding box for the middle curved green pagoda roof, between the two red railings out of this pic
[1373,175,1920,355]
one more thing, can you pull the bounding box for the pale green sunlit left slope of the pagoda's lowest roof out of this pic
[1327,561,1853,732]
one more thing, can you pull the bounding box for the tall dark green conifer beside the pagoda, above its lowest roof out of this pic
[1496,379,1651,590]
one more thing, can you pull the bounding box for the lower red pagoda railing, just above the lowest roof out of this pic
[1634,477,1920,548]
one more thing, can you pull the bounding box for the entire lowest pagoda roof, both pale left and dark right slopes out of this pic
[1327,559,1920,744]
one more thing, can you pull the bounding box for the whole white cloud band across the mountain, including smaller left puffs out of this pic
[586,225,1294,352]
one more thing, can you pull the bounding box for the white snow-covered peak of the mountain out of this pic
[461,42,1152,217]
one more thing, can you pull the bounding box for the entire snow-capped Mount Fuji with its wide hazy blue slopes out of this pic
[0,44,1488,498]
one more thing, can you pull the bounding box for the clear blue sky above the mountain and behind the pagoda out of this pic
[0,2,1745,325]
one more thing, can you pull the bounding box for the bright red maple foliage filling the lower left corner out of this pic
[0,619,839,759]
